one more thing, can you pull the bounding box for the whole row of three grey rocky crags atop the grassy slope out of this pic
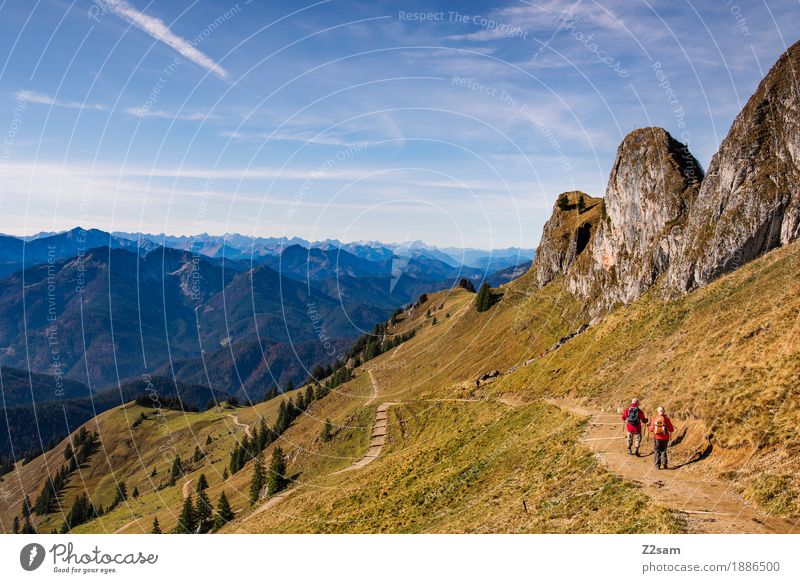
[533,43,800,313]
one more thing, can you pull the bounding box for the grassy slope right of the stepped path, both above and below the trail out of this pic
[230,245,800,532]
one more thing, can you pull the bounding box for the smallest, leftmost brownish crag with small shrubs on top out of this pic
[531,191,602,287]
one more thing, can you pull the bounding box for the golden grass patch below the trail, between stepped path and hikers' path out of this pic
[231,401,684,533]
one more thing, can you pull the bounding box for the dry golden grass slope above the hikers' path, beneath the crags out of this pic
[492,244,800,516]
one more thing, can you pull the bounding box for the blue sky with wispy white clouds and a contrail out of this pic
[0,0,800,248]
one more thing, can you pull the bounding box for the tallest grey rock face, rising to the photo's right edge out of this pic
[667,42,800,293]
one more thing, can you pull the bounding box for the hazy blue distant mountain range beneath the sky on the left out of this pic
[0,227,531,455]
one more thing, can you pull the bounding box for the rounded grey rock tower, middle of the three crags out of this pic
[567,128,703,308]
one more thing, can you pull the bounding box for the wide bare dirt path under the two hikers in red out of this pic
[548,400,798,534]
